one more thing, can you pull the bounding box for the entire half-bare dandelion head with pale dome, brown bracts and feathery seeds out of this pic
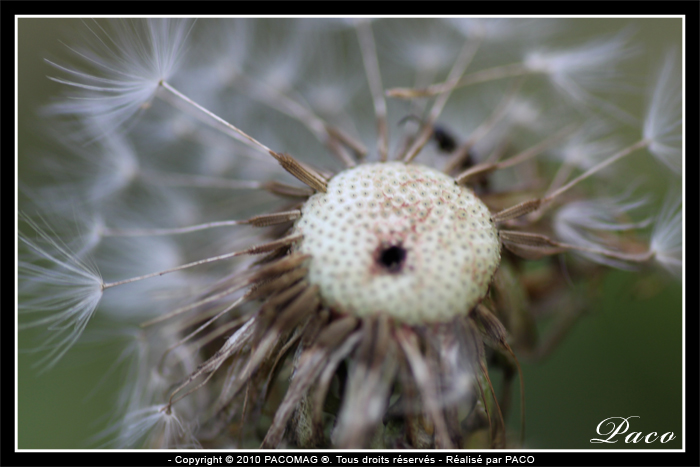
[18,18,683,448]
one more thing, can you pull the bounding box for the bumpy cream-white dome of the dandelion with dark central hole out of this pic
[294,162,500,324]
